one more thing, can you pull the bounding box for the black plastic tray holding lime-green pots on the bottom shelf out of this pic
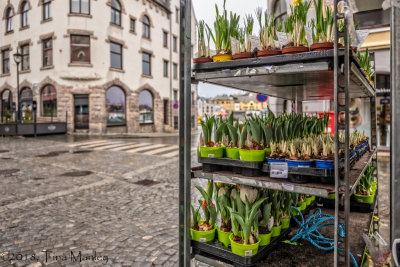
[192,227,291,267]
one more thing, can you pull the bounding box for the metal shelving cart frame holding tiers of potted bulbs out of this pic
[179,0,377,266]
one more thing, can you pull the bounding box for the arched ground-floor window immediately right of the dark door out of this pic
[106,86,126,126]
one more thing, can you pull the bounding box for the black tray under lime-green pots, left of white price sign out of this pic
[198,157,263,177]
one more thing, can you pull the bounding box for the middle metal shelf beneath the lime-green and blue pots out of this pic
[192,150,376,197]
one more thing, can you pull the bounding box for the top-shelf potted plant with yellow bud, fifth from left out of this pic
[282,0,311,54]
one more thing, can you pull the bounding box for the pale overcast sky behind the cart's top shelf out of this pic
[192,0,267,97]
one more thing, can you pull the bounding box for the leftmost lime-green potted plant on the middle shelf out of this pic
[199,115,224,158]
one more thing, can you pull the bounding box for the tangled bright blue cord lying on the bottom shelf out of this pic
[290,207,358,267]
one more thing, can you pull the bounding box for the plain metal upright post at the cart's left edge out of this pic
[179,0,192,267]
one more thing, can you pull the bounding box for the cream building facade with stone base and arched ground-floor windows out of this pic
[0,0,197,134]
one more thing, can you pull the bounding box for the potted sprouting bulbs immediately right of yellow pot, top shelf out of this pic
[232,15,254,59]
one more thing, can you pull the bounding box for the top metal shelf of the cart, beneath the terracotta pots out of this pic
[193,49,375,101]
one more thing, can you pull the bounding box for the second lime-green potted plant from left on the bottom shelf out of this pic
[216,186,232,247]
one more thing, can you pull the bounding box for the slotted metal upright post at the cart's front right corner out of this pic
[334,0,350,266]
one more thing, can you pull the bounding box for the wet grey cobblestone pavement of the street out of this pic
[0,138,389,267]
